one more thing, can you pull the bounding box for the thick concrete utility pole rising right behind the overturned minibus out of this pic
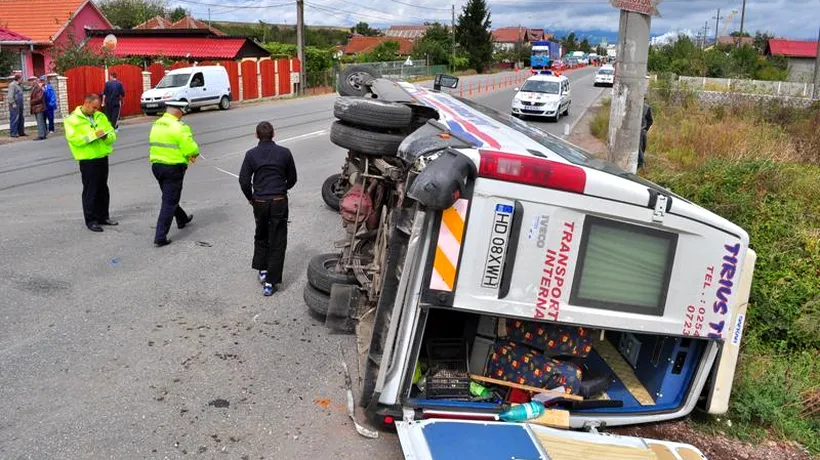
[607,1,657,173]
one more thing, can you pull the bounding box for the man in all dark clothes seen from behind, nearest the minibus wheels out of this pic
[239,121,296,296]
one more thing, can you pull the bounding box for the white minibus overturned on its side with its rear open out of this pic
[305,66,756,458]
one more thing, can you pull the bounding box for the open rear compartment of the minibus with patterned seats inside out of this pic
[404,308,708,416]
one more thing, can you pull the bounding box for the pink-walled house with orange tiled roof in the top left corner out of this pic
[0,0,113,77]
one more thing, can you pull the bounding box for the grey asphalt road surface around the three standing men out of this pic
[0,65,595,459]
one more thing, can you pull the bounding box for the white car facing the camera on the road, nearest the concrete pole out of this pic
[511,71,572,122]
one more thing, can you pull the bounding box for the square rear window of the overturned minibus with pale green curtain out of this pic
[570,216,678,316]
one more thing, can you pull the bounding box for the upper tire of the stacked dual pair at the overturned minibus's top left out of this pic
[333,97,413,128]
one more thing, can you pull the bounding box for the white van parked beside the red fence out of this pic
[140,66,232,115]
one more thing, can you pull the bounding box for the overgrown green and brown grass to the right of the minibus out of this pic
[590,93,820,455]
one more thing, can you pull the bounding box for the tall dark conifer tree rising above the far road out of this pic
[456,0,493,73]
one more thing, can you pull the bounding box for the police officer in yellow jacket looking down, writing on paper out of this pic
[63,94,117,232]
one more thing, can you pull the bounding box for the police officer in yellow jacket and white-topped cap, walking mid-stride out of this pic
[148,101,199,247]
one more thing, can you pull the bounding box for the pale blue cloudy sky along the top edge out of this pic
[169,0,820,40]
